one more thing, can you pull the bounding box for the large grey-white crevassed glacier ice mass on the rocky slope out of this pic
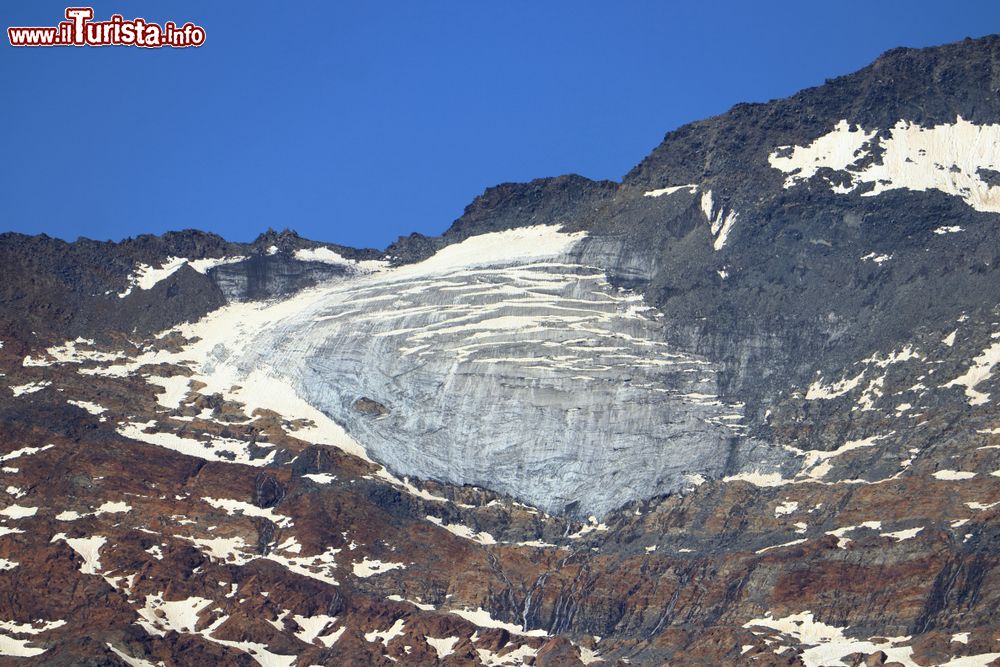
[214,227,741,514]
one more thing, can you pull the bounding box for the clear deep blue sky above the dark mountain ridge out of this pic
[0,0,1000,247]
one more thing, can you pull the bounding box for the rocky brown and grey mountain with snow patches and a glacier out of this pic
[0,37,1000,667]
